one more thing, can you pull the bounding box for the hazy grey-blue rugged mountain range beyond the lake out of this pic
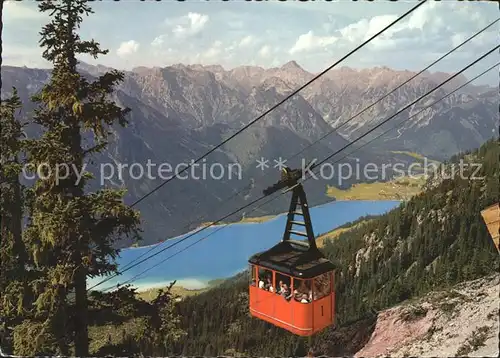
[1,61,498,246]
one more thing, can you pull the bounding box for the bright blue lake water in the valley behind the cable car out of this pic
[88,201,400,290]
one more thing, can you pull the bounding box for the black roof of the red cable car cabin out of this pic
[248,240,336,279]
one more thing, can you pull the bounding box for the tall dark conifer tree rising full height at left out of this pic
[25,0,140,356]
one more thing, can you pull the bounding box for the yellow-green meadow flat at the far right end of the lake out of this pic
[326,175,426,200]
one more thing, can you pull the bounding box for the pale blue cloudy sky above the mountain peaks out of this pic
[2,0,500,85]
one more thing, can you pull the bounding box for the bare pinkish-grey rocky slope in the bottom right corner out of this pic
[355,274,500,357]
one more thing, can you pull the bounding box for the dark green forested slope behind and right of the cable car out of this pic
[162,140,500,356]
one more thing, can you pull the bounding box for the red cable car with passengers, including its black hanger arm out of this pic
[249,168,335,336]
